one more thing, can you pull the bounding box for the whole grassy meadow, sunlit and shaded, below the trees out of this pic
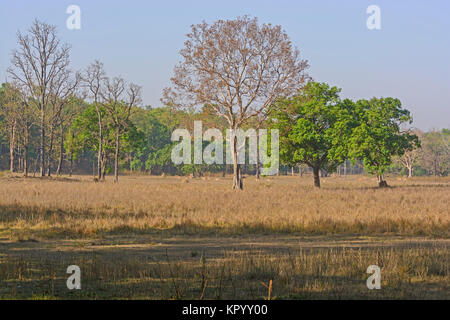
[0,173,450,299]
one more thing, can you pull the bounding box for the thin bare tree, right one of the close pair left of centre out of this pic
[101,77,141,182]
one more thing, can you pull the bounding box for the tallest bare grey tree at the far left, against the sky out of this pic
[8,20,70,176]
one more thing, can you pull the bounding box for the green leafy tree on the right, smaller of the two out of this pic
[349,98,418,187]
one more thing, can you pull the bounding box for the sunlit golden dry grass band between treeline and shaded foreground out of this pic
[0,172,450,239]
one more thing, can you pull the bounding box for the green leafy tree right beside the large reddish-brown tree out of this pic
[269,82,353,187]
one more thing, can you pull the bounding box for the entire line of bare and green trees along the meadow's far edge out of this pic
[0,17,450,189]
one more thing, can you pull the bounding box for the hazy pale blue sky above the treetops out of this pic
[0,0,450,130]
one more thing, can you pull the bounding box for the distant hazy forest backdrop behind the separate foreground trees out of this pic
[0,84,450,180]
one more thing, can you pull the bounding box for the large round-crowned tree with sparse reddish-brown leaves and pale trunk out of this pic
[162,16,308,189]
